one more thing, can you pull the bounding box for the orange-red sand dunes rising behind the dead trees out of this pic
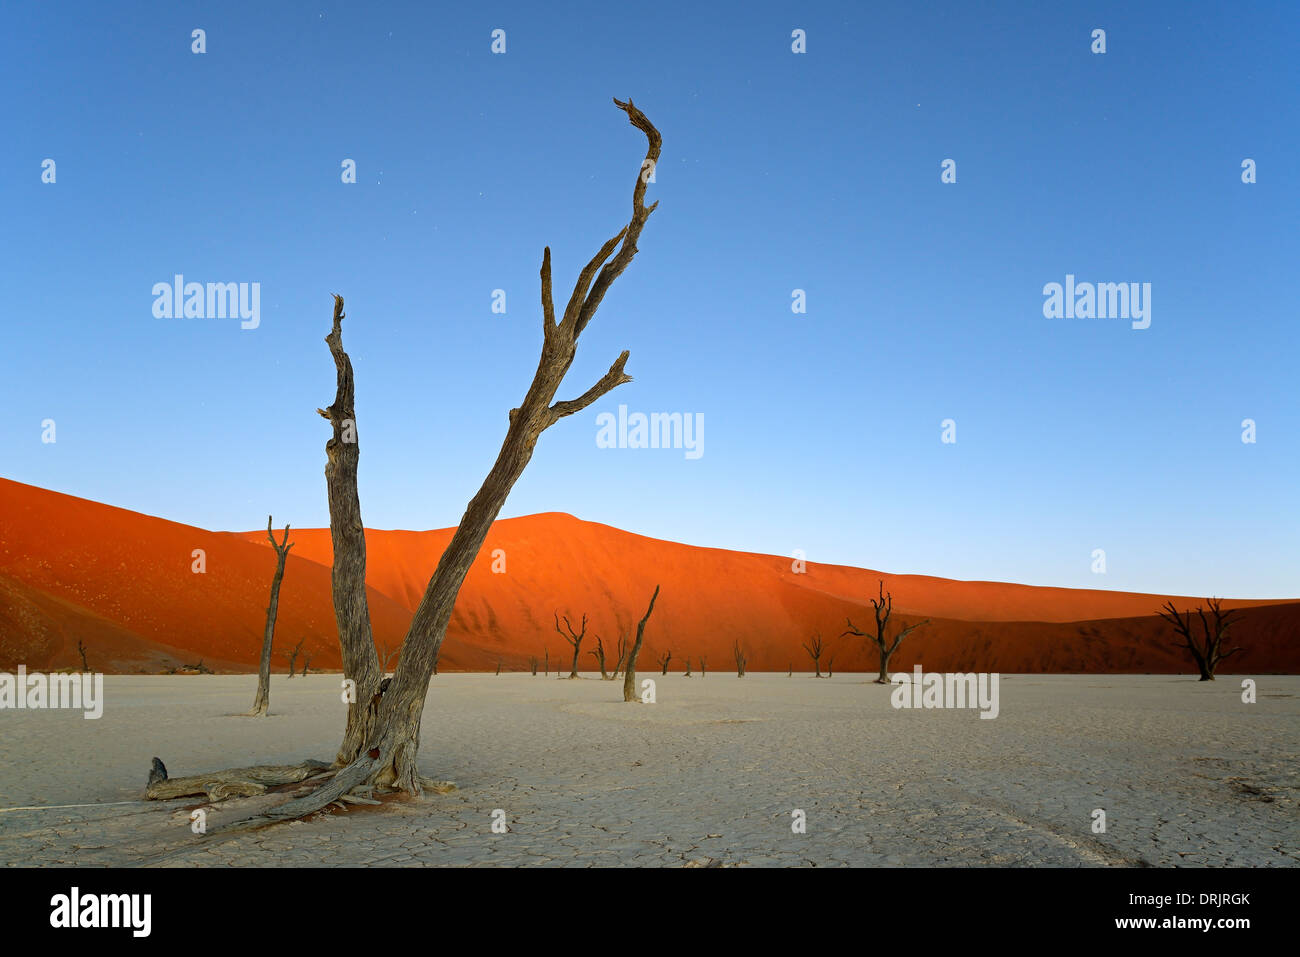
[0,480,1300,674]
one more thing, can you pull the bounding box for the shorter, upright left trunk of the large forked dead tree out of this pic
[316,295,384,766]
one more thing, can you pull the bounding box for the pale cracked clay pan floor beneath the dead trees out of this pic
[0,674,1300,866]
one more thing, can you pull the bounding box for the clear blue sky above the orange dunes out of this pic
[0,1,1300,597]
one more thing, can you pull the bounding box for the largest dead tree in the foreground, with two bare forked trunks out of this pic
[147,100,663,827]
